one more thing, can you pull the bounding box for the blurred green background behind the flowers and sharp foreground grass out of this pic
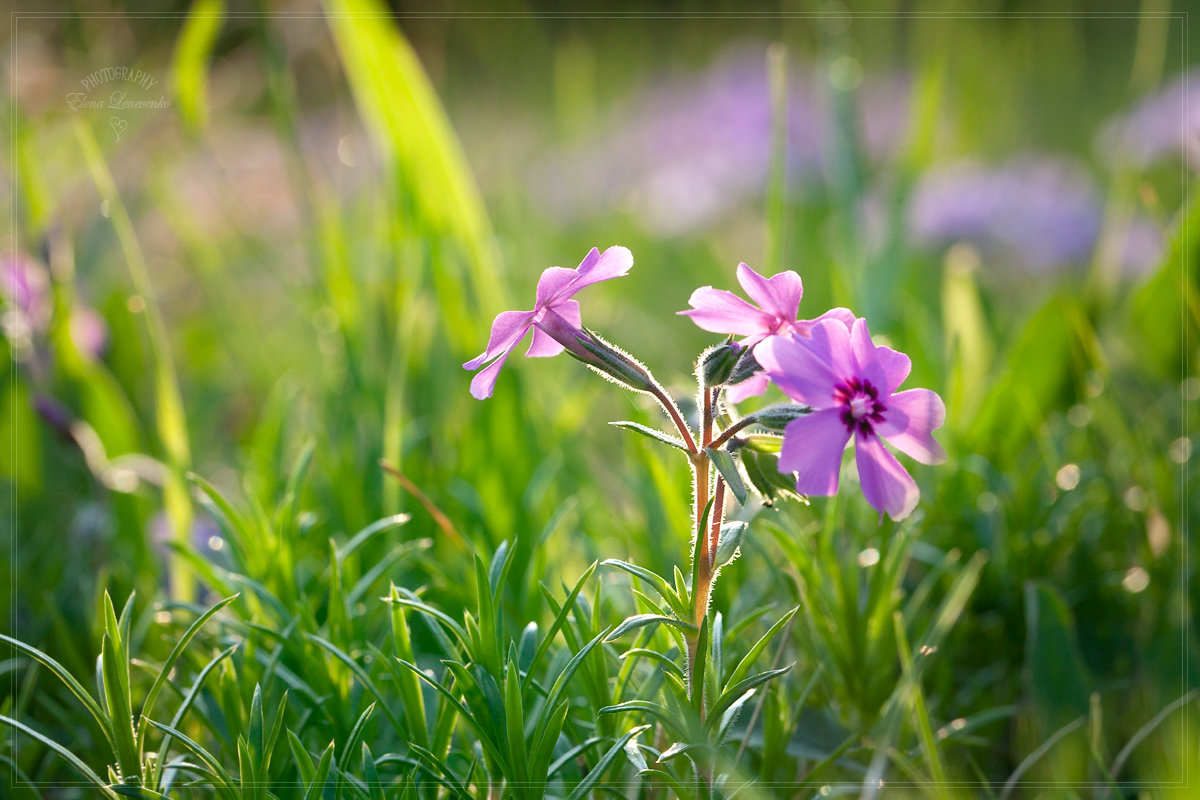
[0,0,1200,796]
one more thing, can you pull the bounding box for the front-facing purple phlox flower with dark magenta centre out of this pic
[756,319,946,521]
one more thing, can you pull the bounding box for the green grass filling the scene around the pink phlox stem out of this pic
[0,2,1200,800]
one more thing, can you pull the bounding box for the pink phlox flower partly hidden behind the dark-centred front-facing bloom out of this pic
[678,263,854,403]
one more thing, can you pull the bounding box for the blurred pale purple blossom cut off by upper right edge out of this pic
[1096,70,1200,170]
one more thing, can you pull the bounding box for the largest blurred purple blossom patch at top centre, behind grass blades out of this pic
[533,47,908,235]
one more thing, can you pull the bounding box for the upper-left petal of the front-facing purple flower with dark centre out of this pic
[754,320,853,408]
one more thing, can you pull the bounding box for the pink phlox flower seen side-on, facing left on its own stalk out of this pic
[462,246,634,399]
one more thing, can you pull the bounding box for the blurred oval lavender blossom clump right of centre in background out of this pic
[908,157,1102,270]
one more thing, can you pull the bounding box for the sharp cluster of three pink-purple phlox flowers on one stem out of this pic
[463,247,946,524]
